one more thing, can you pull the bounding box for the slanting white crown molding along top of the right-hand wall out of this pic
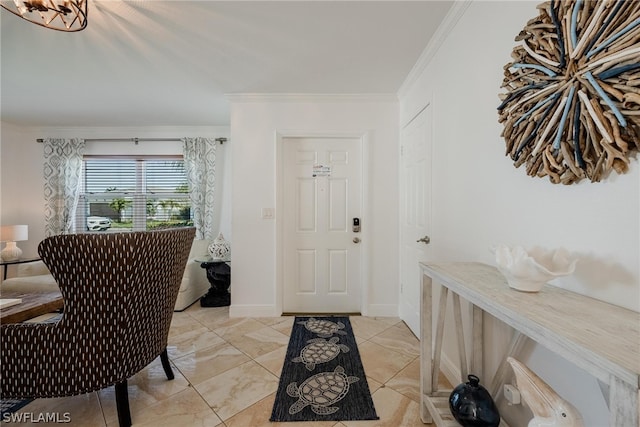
[398,0,474,98]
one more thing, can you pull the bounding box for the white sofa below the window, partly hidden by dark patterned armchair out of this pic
[0,240,210,311]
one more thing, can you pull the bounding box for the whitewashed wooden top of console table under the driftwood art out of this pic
[420,262,640,387]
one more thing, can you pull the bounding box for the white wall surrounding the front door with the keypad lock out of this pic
[230,95,398,316]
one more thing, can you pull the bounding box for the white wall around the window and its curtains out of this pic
[0,123,231,270]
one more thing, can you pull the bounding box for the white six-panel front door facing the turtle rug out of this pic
[283,137,366,313]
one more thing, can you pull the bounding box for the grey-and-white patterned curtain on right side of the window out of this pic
[182,137,216,240]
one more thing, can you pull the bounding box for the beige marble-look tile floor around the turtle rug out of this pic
[7,304,450,427]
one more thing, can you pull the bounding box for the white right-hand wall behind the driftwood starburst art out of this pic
[400,1,640,427]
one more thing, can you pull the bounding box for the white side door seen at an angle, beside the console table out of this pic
[399,104,432,336]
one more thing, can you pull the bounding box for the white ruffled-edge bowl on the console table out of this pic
[495,245,578,292]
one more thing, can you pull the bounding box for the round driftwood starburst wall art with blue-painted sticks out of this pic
[498,0,640,184]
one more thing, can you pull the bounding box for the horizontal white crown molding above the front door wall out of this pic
[226,93,398,103]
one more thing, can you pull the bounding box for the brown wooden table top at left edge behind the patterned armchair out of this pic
[0,292,63,324]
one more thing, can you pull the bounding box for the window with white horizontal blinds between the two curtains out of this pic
[76,156,193,232]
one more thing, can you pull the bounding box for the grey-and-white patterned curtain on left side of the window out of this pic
[43,138,85,237]
